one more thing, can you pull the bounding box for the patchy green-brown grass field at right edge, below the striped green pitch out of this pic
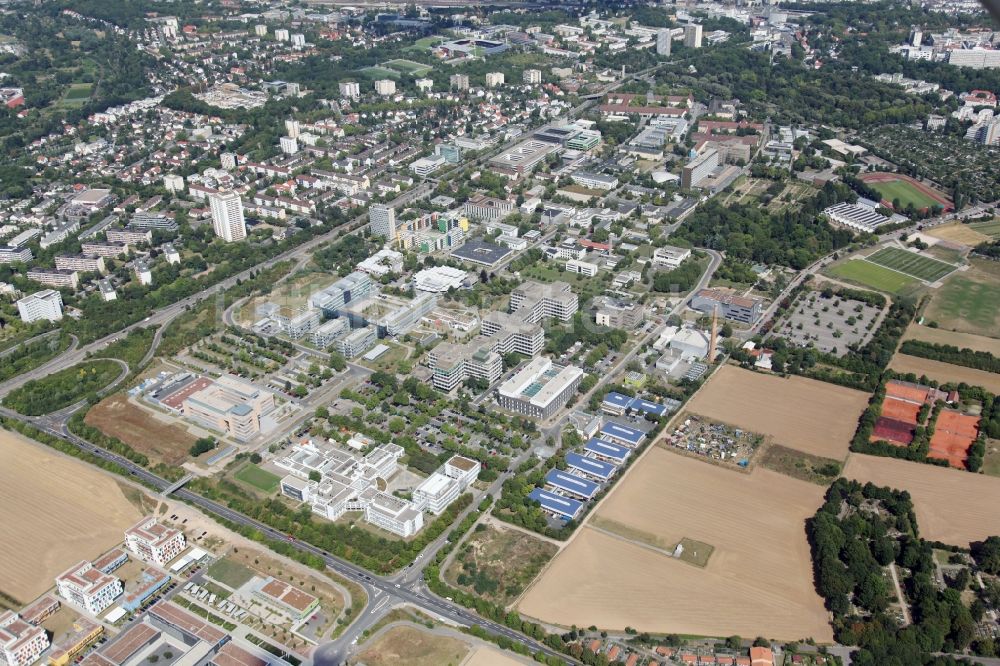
[924,261,1000,337]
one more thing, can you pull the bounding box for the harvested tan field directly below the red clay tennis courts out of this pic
[844,453,1000,547]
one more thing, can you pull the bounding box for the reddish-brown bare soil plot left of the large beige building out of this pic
[84,393,197,465]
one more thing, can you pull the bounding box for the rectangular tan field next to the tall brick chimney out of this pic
[688,365,868,460]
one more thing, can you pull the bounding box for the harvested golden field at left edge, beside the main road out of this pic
[0,429,140,602]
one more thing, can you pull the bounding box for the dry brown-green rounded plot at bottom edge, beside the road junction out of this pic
[350,626,469,666]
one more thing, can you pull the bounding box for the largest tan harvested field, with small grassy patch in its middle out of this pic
[519,448,833,642]
